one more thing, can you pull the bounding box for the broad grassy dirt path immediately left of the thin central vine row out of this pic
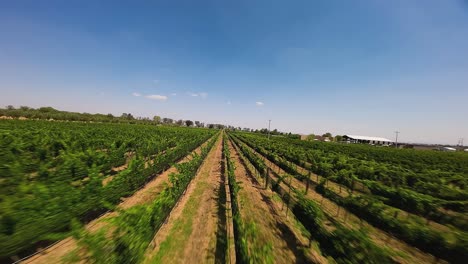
[146,134,225,263]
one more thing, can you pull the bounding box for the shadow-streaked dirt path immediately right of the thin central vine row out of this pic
[228,139,327,263]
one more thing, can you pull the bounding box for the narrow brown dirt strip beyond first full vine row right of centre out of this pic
[238,140,445,263]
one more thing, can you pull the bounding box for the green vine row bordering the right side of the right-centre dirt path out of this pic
[231,135,394,263]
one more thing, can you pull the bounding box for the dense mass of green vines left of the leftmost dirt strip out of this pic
[0,119,213,257]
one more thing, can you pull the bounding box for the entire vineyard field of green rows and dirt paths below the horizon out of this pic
[0,120,468,263]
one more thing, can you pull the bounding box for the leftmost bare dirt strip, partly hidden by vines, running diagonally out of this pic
[21,141,208,264]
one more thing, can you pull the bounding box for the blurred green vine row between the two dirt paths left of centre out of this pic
[71,134,217,263]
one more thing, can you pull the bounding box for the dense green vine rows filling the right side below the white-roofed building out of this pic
[232,133,468,262]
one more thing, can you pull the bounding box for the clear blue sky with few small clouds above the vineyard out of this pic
[0,0,468,144]
